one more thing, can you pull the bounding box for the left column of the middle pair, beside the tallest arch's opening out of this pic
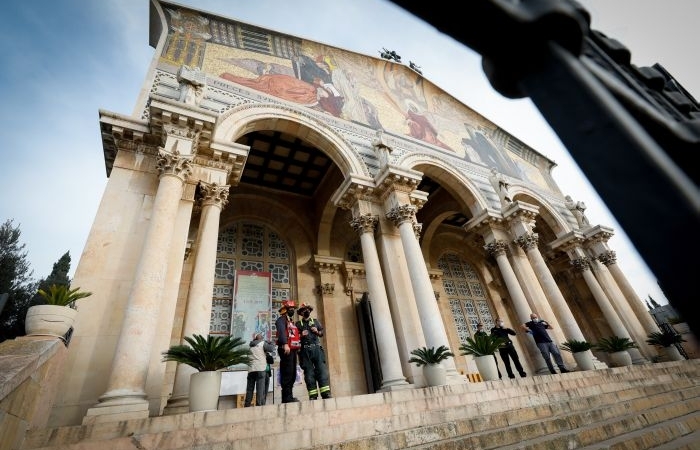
[350,214,408,390]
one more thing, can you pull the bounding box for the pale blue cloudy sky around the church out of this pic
[0,0,700,304]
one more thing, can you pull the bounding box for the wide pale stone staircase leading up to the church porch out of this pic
[22,359,700,450]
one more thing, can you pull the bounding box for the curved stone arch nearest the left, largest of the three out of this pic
[212,103,370,178]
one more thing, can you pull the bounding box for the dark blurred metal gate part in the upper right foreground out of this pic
[392,0,700,333]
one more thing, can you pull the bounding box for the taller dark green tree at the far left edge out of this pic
[0,219,37,342]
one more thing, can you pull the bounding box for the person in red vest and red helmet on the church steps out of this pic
[275,300,299,403]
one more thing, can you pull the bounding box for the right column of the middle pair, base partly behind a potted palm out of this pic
[386,205,463,378]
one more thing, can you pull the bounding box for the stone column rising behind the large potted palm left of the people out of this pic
[163,181,229,414]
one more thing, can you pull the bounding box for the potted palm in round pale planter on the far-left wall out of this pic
[24,284,92,339]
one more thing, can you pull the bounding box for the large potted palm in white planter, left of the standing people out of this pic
[162,334,251,411]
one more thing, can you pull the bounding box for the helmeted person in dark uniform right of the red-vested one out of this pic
[296,303,331,400]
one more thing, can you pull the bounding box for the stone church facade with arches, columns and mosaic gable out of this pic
[49,0,658,426]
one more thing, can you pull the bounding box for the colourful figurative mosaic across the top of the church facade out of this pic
[160,5,551,189]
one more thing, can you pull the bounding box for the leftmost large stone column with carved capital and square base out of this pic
[88,150,191,417]
